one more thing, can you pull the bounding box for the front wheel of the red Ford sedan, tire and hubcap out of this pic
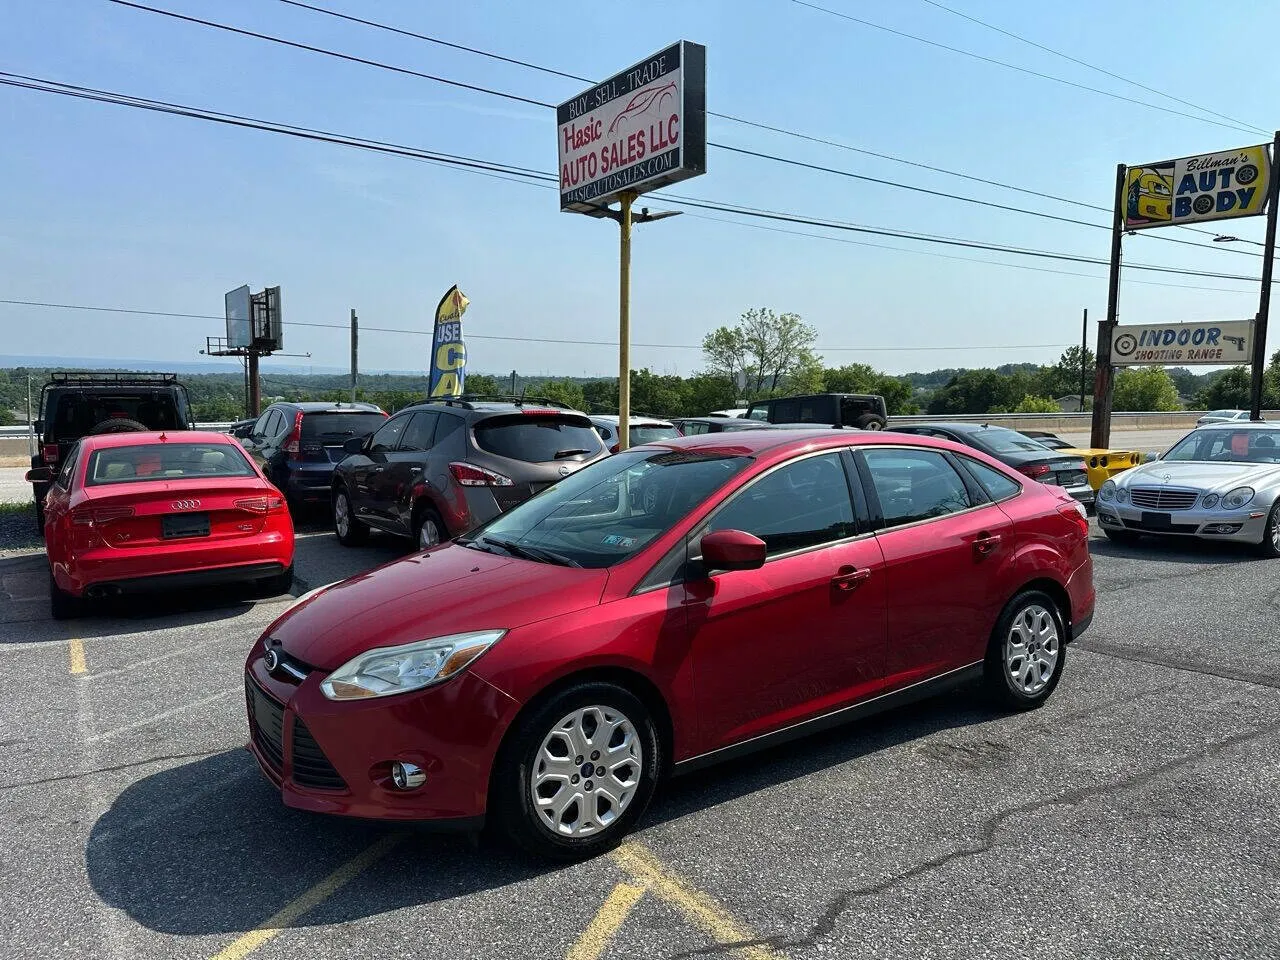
[489,682,663,860]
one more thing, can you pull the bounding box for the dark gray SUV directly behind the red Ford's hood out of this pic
[332,397,608,549]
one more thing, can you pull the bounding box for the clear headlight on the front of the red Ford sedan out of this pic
[320,630,507,700]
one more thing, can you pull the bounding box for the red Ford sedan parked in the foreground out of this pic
[244,430,1094,859]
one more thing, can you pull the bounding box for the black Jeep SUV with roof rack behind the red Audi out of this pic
[31,371,195,532]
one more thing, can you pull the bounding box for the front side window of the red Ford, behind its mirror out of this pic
[707,452,855,556]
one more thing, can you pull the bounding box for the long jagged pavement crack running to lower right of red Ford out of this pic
[672,721,1280,960]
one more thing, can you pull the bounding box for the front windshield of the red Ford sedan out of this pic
[460,451,750,567]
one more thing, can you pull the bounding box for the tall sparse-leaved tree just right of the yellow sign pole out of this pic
[703,307,818,397]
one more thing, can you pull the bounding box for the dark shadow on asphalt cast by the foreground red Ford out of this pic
[86,689,1002,936]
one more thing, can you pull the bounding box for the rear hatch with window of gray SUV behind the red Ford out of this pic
[475,411,605,511]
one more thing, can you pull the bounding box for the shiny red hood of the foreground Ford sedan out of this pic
[268,544,608,671]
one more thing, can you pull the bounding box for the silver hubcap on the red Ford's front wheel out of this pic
[529,707,643,837]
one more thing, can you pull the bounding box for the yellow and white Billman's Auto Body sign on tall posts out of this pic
[1124,143,1271,230]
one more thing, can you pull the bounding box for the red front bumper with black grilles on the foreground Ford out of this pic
[244,643,520,828]
